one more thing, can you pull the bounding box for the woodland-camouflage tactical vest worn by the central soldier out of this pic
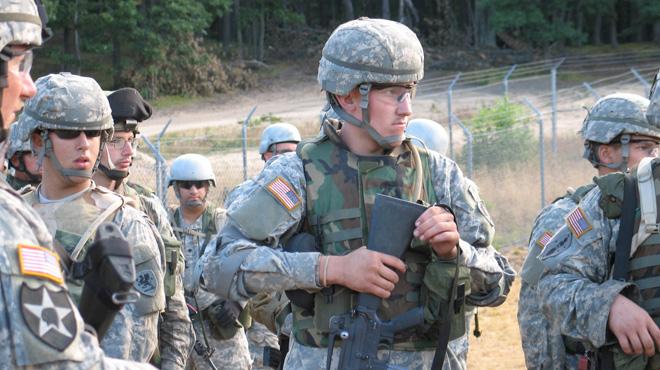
[292,128,438,350]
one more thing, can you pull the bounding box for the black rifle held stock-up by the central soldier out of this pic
[326,194,426,370]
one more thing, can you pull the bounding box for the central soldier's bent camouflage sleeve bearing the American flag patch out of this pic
[200,153,320,301]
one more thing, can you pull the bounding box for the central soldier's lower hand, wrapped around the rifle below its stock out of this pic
[321,247,406,298]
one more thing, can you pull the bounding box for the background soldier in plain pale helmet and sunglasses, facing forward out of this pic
[168,154,252,369]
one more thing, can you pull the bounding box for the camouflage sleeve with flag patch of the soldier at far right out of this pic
[538,189,630,347]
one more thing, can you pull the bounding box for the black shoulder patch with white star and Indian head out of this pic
[20,283,78,351]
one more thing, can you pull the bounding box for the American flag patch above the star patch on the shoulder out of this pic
[18,244,64,284]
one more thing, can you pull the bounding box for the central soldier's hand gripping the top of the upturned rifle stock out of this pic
[413,207,460,259]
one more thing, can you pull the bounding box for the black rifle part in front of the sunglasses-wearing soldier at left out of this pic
[74,222,139,341]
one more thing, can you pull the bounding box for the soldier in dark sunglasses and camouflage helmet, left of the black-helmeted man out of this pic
[18,73,165,362]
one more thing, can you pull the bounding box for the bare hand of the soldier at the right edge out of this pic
[607,294,660,357]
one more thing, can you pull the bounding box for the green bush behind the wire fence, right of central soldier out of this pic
[470,99,537,168]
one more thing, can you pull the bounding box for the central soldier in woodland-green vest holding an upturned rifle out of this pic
[203,18,514,369]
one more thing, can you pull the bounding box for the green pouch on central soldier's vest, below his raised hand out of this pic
[422,257,470,340]
